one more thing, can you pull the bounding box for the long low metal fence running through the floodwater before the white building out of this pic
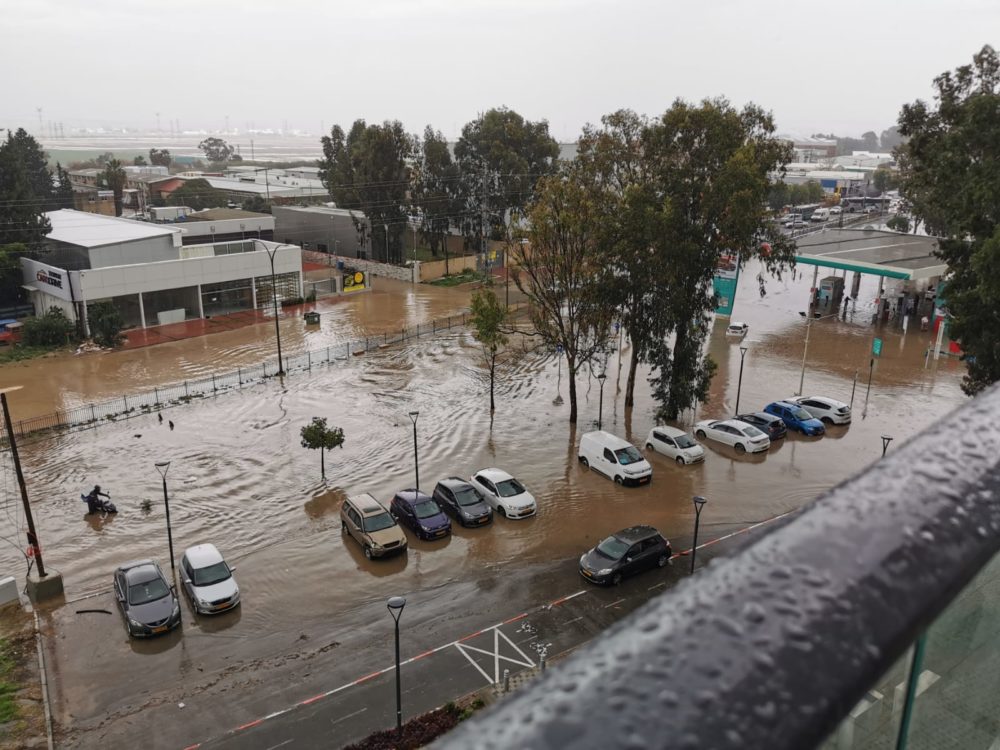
[5,304,522,444]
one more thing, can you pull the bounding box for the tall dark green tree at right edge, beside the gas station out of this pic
[898,45,1000,395]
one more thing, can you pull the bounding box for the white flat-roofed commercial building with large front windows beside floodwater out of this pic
[21,209,302,335]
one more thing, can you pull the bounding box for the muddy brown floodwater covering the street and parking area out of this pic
[0,258,964,748]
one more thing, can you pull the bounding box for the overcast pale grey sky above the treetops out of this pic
[0,0,1000,140]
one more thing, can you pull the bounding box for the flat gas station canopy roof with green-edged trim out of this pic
[795,229,948,281]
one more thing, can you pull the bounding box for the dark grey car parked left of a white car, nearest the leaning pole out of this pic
[114,560,181,638]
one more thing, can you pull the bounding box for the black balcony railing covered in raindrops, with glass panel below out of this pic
[437,387,1000,750]
